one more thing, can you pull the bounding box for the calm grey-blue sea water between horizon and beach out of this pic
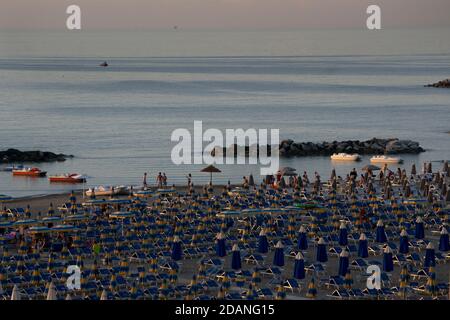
[0,29,450,196]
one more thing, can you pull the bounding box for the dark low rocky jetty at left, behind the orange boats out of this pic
[0,149,73,163]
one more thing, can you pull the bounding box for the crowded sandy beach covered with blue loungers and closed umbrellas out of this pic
[0,166,449,300]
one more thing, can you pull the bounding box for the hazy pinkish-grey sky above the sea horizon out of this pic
[0,0,450,30]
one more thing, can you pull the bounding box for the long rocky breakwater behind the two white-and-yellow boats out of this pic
[211,138,425,157]
